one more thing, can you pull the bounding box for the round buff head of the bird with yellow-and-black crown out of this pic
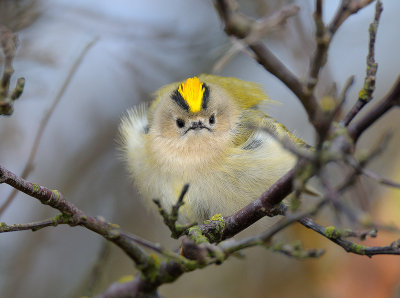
[149,78,239,172]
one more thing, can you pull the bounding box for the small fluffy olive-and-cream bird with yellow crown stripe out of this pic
[120,74,305,223]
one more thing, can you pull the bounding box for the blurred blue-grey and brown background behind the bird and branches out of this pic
[0,0,400,298]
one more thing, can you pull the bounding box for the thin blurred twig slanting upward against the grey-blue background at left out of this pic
[0,38,98,216]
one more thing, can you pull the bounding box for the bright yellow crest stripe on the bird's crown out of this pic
[178,77,205,113]
